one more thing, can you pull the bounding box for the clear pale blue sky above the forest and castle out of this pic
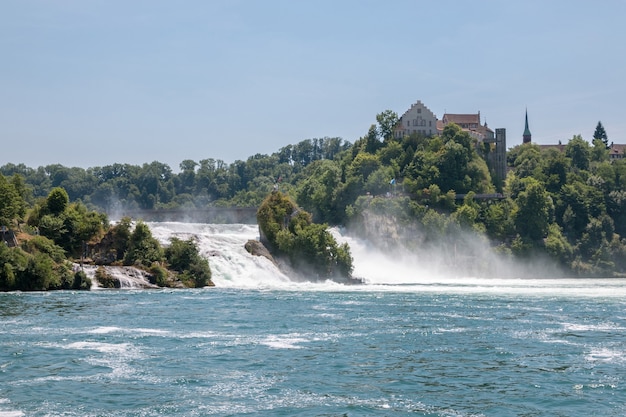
[0,0,626,171]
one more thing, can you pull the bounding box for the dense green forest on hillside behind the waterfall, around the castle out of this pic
[0,111,626,276]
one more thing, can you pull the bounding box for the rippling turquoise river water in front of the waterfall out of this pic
[0,286,626,417]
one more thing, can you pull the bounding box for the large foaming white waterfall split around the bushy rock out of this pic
[143,222,626,297]
